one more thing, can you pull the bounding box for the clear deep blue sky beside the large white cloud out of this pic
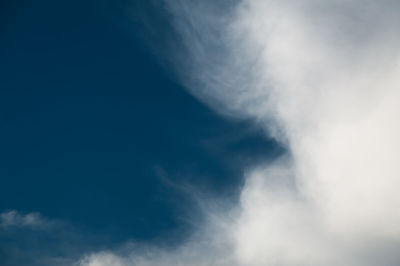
[0,0,281,265]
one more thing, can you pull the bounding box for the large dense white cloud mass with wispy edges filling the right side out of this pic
[81,0,400,266]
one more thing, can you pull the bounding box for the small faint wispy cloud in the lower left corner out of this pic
[0,210,98,266]
